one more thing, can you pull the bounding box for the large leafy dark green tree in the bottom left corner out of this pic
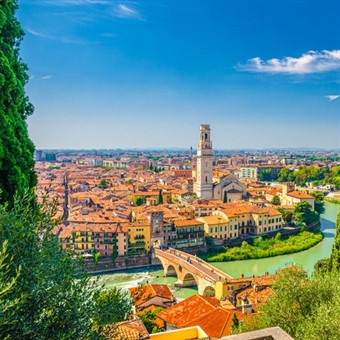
[0,195,100,339]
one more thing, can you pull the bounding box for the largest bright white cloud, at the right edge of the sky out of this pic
[238,50,340,74]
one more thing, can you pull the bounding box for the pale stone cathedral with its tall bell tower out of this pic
[195,124,246,202]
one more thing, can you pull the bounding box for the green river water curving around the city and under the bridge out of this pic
[100,202,340,299]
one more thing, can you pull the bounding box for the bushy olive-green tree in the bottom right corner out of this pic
[235,267,340,340]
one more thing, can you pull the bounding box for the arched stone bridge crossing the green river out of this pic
[155,248,233,299]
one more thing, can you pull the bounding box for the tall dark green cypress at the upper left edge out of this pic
[0,0,36,206]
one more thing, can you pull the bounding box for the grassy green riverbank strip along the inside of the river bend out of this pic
[200,231,323,262]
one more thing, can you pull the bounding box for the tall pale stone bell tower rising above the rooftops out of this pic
[196,124,213,199]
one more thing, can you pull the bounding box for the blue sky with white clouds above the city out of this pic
[18,0,340,149]
